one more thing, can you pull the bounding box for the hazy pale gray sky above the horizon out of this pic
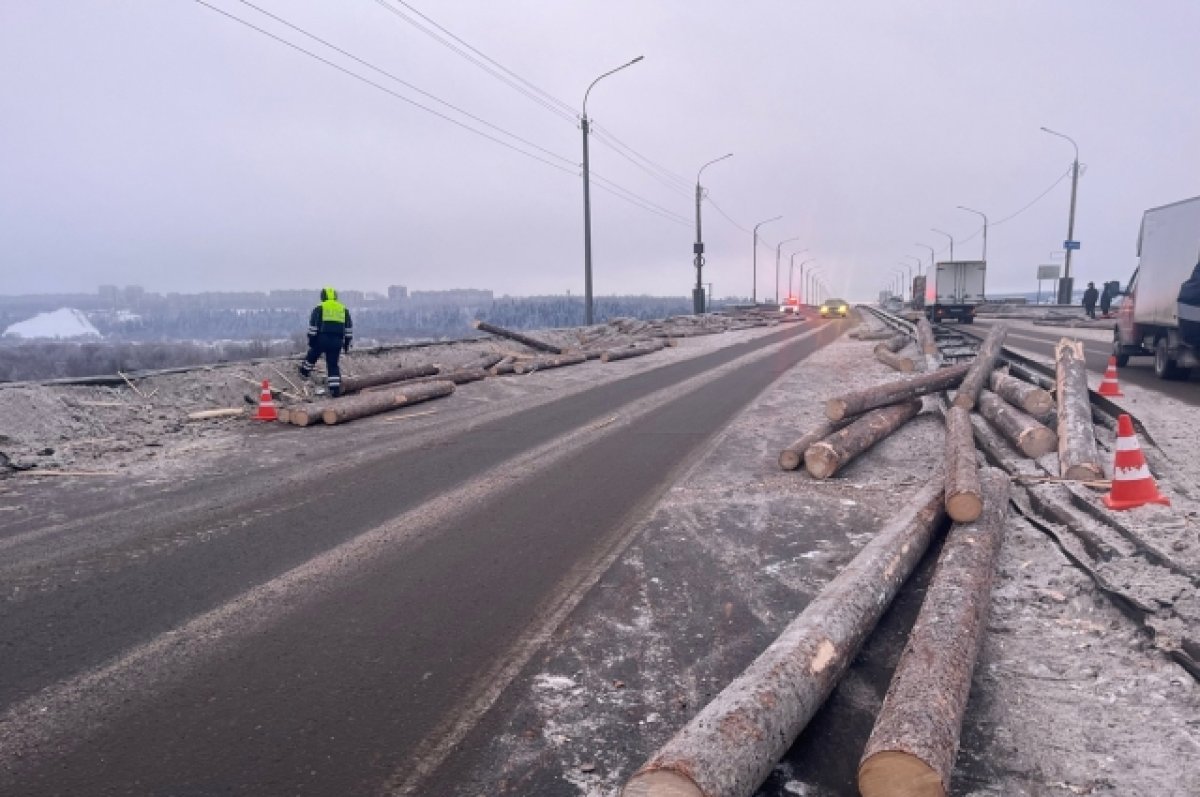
[0,0,1200,298]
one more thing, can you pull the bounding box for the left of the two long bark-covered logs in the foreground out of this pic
[622,485,943,797]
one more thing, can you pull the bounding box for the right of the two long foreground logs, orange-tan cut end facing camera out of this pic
[858,468,1009,797]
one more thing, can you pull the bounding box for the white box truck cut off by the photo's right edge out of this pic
[1112,197,1200,379]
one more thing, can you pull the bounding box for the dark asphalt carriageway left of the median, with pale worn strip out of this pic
[0,322,844,797]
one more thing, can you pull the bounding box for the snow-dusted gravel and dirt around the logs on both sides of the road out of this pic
[0,312,1200,797]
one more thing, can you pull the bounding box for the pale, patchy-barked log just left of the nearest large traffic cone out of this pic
[1055,337,1104,481]
